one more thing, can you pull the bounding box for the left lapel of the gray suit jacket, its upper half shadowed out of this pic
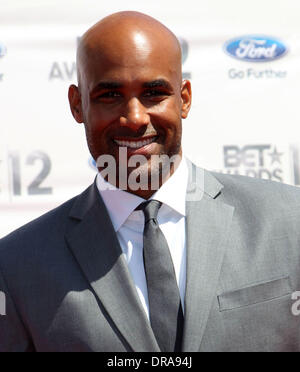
[66,185,159,352]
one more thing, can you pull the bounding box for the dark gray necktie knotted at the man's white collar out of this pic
[137,200,183,352]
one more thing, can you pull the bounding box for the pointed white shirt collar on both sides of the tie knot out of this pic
[96,158,188,231]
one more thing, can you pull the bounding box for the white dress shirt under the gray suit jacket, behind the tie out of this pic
[97,158,188,318]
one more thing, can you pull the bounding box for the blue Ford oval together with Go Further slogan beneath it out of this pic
[223,35,288,80]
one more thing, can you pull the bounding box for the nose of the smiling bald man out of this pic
[120,97,150,127]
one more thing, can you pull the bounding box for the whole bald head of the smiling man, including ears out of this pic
[69,12,191,199]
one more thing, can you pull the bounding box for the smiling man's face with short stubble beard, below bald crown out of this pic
[70,30,190,198]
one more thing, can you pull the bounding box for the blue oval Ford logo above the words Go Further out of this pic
[224,35,288,62]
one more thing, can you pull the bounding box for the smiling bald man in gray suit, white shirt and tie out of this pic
[0,12,300,352]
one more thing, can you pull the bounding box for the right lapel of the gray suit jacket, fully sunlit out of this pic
[183,164,234,352]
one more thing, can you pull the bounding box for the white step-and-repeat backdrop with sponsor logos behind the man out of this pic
[0,0,300,237]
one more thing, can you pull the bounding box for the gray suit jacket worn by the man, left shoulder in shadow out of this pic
[0,161,300,352]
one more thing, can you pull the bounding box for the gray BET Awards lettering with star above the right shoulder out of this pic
[223,144,284,182]
